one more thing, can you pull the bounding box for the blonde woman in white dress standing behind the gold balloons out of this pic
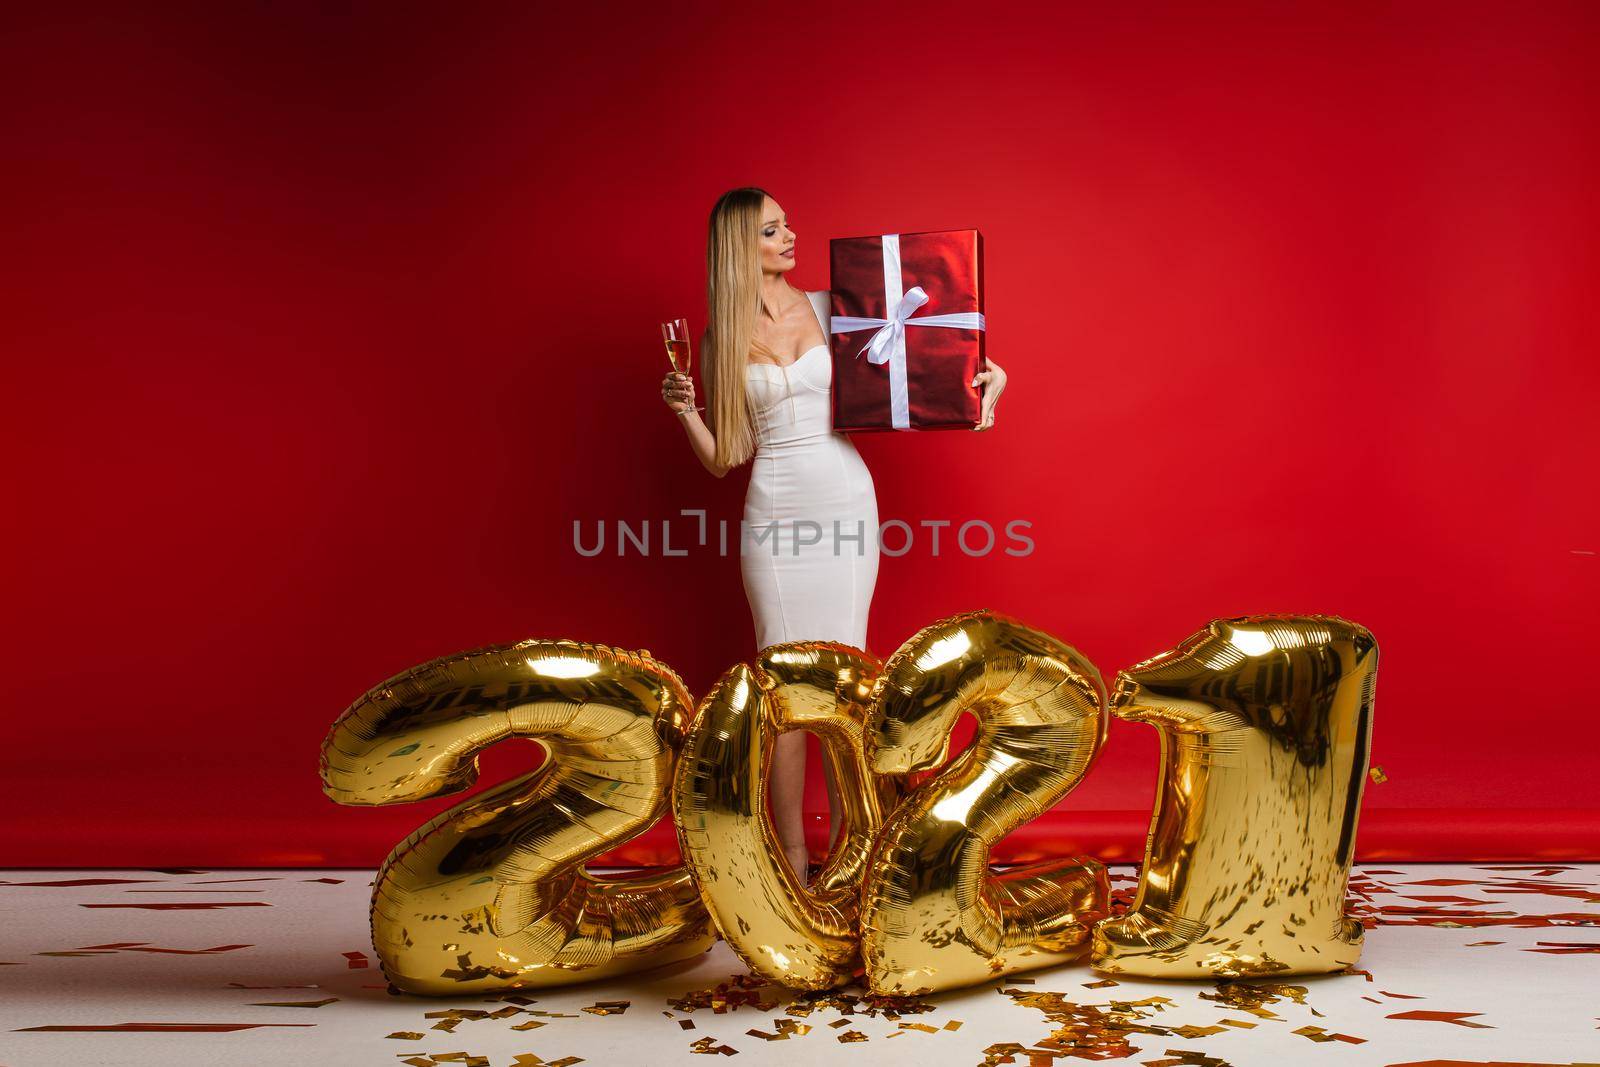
[661,189,1005,881]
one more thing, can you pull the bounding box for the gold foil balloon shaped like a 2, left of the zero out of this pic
[322,640,715,995]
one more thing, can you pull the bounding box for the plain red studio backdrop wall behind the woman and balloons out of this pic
[0,2,1600,865]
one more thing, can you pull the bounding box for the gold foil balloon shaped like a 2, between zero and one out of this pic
[861,611,1110,995]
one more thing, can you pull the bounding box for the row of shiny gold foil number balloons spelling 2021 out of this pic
[322,611,1378,995]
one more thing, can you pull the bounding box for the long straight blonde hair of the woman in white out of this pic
[701,186,771,467]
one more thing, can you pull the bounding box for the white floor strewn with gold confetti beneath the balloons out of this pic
[0,864,1600,1067]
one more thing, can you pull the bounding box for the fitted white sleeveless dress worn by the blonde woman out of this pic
[739,293,878,649]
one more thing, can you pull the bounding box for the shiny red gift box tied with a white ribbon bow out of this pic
[829,230,987,430]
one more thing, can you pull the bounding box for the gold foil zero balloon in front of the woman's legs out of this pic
[672,641,899,989]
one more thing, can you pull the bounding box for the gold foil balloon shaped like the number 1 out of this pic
[1090,616,1378,977]
